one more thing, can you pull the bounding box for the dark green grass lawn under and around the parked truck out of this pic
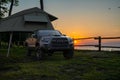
[0,48,120,80]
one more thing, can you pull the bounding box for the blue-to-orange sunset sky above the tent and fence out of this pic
[13,0,120,37]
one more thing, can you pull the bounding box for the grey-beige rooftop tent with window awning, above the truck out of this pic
[0,7,57,32]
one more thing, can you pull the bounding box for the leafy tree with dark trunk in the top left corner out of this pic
[0,0,18,18]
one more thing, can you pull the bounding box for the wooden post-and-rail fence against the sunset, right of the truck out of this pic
[73,36,120,51]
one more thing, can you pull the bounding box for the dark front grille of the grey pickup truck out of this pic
[51,38,68,48]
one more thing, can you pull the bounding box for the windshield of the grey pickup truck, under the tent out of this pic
[38,30,62,37]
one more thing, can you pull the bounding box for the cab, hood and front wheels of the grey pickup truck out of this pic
[27,30,74,59]
